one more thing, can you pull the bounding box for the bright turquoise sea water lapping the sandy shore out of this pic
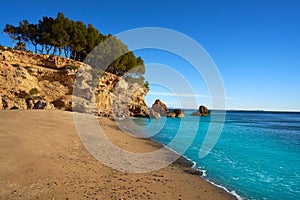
[134,111,300,199]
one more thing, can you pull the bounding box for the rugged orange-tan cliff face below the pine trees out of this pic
[0,47,148,117]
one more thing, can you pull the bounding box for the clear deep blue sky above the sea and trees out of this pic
[0,0,300,111]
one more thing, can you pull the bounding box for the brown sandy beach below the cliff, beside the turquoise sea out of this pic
[0,110,235,199]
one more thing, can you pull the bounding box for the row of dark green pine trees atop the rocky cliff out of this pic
[3,13,145,78]
